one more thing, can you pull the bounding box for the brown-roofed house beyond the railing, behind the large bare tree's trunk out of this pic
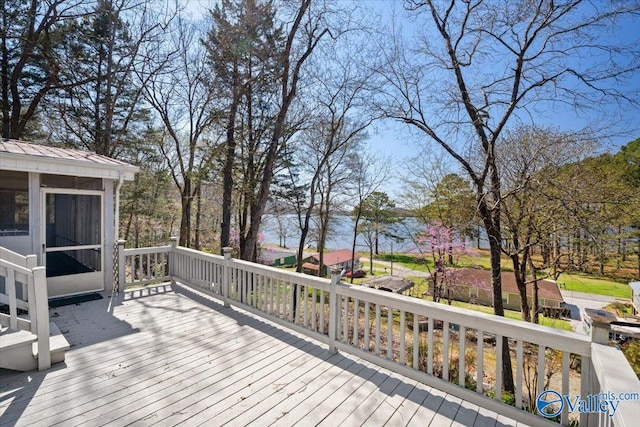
[429,268,564,311]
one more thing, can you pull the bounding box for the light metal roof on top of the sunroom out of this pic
[0,139,139,180]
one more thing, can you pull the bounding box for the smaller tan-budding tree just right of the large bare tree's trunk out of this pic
[498,126,594,323]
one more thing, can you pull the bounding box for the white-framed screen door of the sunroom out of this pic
[41,189,104,298]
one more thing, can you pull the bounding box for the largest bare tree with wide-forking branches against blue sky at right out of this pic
[383,0,640,392]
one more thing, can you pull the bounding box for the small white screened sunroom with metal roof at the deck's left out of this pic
[0,140,138,298]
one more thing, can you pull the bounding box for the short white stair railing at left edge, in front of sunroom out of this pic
[0,247,51,371]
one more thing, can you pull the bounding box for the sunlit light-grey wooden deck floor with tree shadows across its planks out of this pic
[0,285,528,427]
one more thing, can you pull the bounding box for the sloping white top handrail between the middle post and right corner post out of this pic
[337,282,591,356]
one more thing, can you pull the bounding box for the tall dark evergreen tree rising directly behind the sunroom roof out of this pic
[49,0,151,160]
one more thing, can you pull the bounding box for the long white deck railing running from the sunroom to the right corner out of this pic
[119,240,640,426]
